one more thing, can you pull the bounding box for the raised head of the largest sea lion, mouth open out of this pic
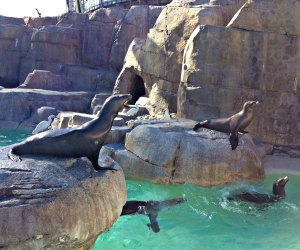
[102,94,132,116]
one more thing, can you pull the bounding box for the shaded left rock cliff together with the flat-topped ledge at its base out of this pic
[0,6,163,127]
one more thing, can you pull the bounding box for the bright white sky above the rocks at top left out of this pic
[0,0,67,17]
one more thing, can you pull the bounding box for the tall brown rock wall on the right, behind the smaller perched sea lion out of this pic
[178,0,300,155]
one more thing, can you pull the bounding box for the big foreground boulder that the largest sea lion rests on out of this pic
[0,148,126,249]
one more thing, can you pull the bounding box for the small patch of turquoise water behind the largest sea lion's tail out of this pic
[0,129,32,147]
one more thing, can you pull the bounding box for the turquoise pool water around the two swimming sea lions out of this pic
[92,174,300,250]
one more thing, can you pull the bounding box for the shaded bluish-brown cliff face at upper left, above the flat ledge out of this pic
[0,6,162,90]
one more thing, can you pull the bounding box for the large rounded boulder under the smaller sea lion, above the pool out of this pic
[101,121,267,186]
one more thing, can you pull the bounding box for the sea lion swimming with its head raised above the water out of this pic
[228,176,289,204]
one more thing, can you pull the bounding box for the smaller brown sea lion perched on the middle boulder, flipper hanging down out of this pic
[193,101,259,150]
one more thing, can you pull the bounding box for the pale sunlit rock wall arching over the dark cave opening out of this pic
[115,0,244,113]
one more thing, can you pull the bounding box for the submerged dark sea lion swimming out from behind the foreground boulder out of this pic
[121,198,186,233]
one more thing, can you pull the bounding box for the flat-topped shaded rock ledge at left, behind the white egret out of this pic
[0,88,93,129]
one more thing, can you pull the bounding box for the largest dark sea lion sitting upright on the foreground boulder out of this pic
[8,94,131,170]
